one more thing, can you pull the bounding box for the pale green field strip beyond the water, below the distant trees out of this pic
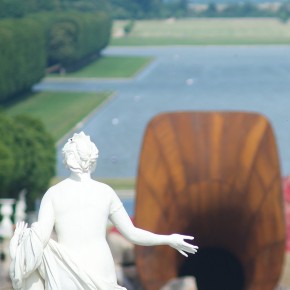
[111,18,290,46]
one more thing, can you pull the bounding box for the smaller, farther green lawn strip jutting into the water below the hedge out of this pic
[50,56,152,78]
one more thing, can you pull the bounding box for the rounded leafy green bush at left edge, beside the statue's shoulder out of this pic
[0,113,56,208]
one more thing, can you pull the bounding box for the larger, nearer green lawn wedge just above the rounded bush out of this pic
[6,92,112,140]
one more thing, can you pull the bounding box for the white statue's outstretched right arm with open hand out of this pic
[110,207,198,257]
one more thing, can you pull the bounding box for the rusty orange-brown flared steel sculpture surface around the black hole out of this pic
[135,112,285,290]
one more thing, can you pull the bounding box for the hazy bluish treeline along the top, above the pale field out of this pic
[109,0,290,21]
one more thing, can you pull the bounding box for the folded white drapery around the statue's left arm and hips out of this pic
[10,219,126,290]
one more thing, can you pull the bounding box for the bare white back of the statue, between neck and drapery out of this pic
[51,179,116,282]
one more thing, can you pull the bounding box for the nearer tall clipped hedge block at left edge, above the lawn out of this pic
[0,18,46,101]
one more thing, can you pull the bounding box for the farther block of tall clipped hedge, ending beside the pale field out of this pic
[31,12,112,67]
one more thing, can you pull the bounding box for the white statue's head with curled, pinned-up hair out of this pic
[62,132,99,173]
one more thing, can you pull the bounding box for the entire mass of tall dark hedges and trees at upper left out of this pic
[0,0,112,102]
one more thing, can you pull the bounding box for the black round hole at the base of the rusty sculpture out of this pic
[179,248,245,290]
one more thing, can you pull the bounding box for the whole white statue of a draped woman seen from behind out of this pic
[10,132,198,290]
